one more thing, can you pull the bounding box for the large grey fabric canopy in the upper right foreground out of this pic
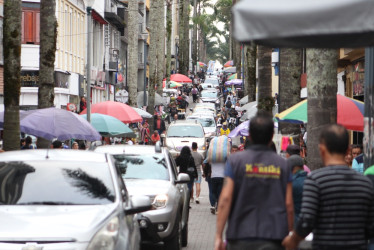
[232,0,374,48]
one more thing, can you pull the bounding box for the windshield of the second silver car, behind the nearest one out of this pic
[113,154,170,180]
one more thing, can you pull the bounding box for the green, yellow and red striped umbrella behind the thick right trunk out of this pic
[275,94,364,131]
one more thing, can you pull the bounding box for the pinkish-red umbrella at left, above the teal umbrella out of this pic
[80,101,142,123]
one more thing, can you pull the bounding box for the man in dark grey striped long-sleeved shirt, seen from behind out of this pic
[284,124,374,250]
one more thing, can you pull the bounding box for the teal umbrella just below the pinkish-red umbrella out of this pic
[82,113,133,137]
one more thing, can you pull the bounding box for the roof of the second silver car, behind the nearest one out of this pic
[94,144,165,155]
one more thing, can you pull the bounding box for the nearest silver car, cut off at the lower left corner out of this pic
[0,149,150,250]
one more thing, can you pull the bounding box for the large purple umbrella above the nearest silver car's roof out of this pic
[4,108,101,141]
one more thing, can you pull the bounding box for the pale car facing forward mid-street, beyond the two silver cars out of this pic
[165,120,206,157]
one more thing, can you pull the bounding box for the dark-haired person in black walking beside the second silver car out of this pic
[175,146,197,197]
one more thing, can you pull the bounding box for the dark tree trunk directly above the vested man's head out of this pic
[257,46,274,113]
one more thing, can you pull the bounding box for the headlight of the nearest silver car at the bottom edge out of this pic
[87,217,119,250]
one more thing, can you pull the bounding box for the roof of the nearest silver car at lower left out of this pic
[0,149,108,162]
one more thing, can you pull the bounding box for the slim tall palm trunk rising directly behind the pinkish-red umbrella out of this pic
[127,0,140,107]
